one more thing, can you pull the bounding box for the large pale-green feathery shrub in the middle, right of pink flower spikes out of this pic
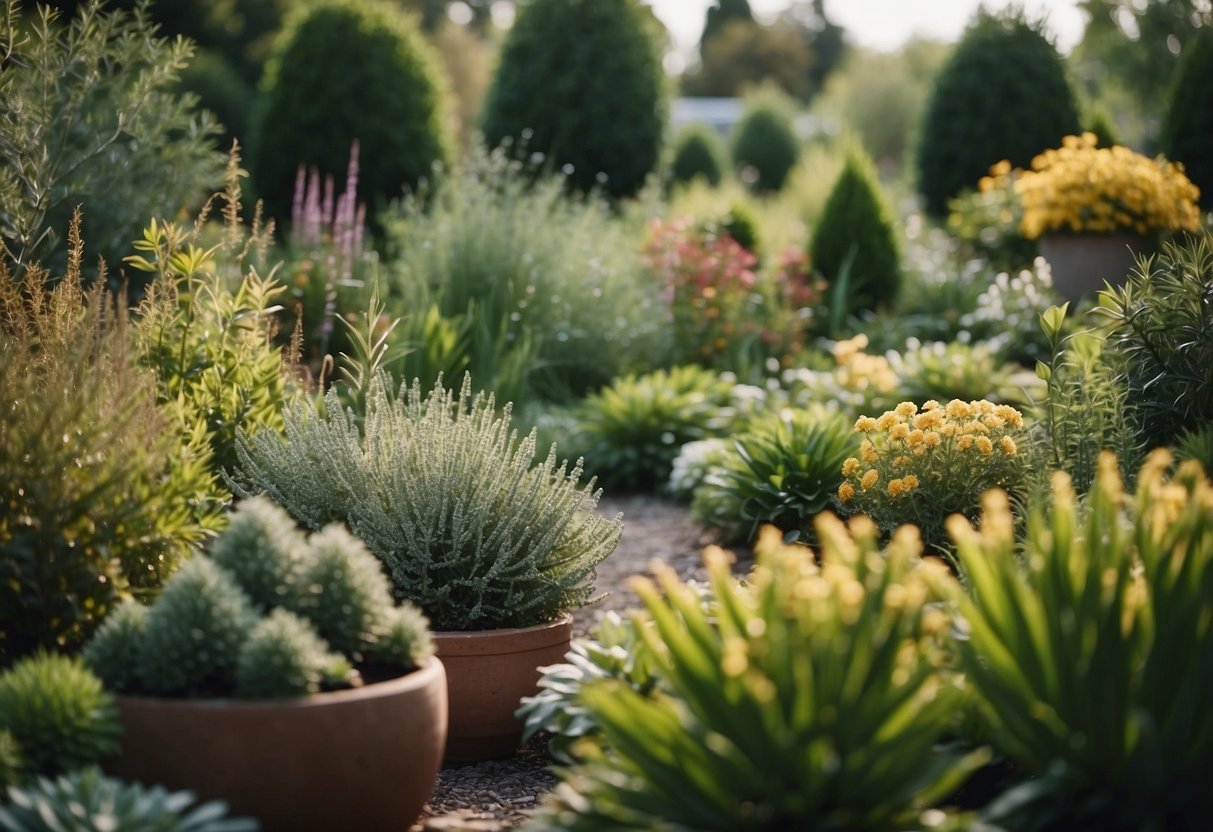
[387,147,664,406]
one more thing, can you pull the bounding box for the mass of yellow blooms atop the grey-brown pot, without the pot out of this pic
[978,132,1200,239]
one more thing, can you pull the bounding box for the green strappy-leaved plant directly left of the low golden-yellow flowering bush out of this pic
[691,410,859,543]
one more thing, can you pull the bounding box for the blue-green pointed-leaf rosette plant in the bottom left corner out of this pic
[0,768,261,832]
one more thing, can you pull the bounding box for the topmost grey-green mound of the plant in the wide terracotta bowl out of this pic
[209,497,306,611]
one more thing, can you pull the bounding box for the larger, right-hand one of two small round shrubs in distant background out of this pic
[731,89,801,193]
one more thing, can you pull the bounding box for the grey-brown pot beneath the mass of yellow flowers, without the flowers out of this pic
[1041,234,1149,301]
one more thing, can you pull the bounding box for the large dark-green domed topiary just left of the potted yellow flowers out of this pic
[917,10,1080,218]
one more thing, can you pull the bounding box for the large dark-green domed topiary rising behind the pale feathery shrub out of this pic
[484,0,665,196]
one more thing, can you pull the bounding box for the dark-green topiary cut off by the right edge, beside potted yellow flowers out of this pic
[1161,27,1213,210]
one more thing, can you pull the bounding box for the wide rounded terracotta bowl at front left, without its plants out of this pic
[106,659,446,832]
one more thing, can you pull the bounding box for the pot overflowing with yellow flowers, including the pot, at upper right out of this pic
[979,132,1200,301]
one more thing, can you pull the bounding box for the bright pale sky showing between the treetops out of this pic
[650,0,1086,52]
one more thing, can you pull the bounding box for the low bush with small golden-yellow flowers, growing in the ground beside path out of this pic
[838,399,1027,553]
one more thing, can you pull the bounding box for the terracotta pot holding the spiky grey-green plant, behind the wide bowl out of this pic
[434,615,573,763]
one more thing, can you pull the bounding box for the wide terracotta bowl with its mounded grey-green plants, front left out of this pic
[84,498,446,830]
